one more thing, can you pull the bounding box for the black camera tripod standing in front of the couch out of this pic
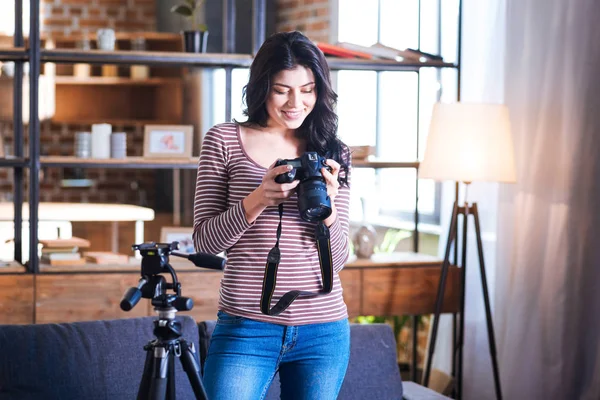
[121,242,225,400]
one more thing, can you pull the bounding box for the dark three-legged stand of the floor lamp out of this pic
[423,201,502,400]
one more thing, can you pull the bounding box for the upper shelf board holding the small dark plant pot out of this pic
[41,49,252,68]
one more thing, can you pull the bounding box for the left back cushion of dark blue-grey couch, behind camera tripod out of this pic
[0,316,198,400]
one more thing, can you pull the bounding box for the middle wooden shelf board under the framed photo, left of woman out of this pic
[40,156,198,169]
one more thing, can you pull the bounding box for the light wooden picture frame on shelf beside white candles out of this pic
[144,125,194,158]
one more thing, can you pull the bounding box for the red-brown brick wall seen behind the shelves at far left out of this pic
[0,0,156,206]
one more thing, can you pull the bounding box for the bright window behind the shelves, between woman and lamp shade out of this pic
[335,0,458,226]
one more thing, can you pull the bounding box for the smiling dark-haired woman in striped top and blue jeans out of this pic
[194,32,350,400]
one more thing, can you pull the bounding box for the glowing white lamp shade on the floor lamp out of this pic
[419,103,516,183]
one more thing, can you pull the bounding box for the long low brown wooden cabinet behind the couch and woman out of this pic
[0,253,461,324]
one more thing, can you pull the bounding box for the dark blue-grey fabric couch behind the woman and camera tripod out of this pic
[0,316,447,400]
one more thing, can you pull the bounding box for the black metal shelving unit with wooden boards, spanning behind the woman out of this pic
[0,0,462,274]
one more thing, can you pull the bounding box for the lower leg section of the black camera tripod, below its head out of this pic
[137,307,207,400]
